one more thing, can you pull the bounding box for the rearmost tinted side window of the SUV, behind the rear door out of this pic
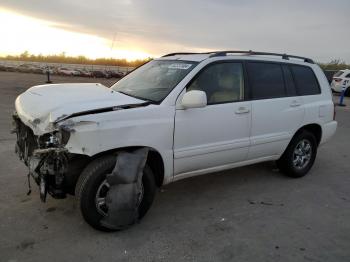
[291,65,320,96]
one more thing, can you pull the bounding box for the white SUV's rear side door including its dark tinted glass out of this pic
[246,61,304,160]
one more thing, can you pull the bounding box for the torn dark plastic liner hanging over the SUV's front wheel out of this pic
[101,148,148,230]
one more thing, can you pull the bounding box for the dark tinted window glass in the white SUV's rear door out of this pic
[247,63,286,99]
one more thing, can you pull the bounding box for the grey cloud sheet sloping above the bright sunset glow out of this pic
[1,0,350,62]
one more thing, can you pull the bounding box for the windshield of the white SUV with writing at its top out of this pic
[111,60,197,103]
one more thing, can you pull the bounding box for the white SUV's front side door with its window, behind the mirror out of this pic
[174,62,251,179]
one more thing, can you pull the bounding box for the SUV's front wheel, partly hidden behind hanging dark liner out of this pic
[75,156,156,231]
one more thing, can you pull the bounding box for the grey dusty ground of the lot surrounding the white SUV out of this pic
[0,72,350,262]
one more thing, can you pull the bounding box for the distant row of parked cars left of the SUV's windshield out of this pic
[0,64,125,78]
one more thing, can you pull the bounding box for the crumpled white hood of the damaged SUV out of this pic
[15,83,145,135]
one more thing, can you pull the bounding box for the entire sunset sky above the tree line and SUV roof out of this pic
[0,0,350,63]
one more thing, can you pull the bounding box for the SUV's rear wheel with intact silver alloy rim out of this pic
[277,130,317,178]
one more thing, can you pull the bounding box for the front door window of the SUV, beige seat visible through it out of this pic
[187,63,244,104]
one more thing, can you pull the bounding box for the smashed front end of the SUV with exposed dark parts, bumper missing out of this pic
[12,112,70,201]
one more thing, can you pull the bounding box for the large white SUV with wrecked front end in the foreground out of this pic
[14,51,337,230]
